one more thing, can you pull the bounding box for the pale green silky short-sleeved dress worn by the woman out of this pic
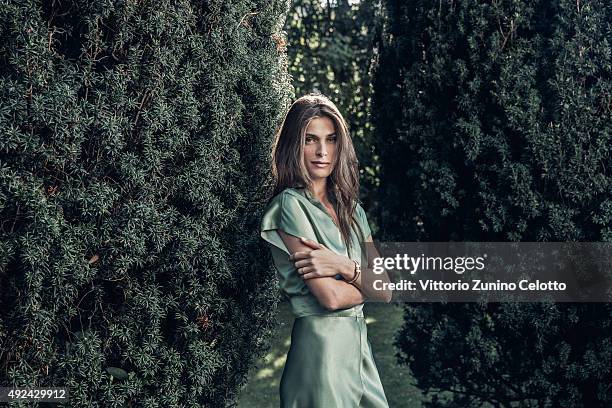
[261,188,388,408]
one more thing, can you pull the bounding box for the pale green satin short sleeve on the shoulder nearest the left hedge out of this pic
[261,192,318,254]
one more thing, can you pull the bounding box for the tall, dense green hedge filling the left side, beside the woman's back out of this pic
[0,0,289,407]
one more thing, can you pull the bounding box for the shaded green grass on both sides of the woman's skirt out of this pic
[238,302,426,408]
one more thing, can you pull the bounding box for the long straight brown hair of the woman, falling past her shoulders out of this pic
[272,94,365,251]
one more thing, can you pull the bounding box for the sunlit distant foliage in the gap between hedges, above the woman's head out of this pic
[285,0,381,202]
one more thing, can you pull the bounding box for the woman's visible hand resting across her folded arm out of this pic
[289,237,354,279]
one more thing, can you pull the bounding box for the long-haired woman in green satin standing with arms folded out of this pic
[261,95,390,408]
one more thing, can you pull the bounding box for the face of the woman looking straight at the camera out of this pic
[304,116,338,180]
